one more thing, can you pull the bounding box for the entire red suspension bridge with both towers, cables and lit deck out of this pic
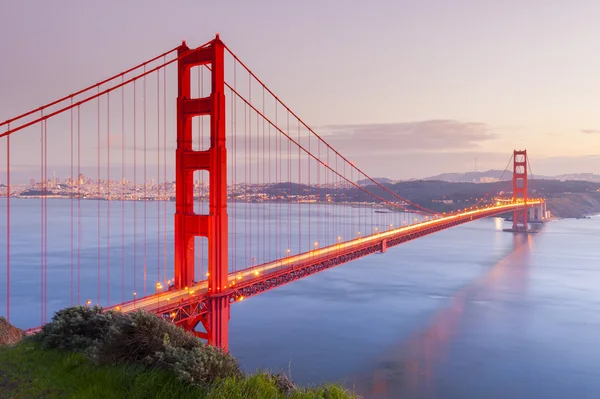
[0,35,545,350]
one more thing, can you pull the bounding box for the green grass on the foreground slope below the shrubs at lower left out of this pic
[0,340,356,399]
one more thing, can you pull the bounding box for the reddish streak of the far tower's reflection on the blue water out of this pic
[352,236,533,399]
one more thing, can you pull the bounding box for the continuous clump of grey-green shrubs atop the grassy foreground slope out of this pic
[36,306,243,385]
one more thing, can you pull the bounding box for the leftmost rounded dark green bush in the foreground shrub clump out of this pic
[36,306,124,353]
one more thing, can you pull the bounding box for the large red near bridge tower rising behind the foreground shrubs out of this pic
[175,34,230,350]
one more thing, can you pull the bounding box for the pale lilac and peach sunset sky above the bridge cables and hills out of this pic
[0,0,600,179]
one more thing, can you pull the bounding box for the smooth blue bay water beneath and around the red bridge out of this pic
[0,201,600,398]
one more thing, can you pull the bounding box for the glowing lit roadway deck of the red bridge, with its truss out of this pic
[109,200,542,324]
